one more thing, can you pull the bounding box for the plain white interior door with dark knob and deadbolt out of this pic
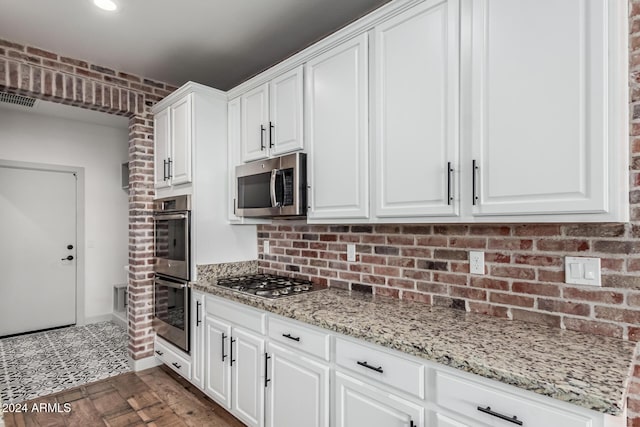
[0,166,76,336]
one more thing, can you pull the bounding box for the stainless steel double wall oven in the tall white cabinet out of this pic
[153,195,191,352]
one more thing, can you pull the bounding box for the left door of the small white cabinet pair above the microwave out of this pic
[241,83,269,162]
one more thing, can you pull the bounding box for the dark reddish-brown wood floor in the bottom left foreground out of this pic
[4,366,244,427]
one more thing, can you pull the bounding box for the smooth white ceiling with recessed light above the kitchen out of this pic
[0,0,389,90]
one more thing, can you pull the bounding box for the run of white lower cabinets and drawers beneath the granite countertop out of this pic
[188,293,626,427]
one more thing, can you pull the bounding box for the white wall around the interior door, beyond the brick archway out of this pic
[0,106,129,321]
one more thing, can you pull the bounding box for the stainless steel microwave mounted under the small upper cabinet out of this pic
[235,153,307,218]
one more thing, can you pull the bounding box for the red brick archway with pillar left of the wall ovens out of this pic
[0,39,176,359]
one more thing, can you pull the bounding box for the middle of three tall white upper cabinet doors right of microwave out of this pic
[374,0,459,217]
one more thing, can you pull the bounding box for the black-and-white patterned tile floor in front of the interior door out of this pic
[0,322,131,408]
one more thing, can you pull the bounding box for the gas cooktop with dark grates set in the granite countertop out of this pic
[217,274,325,299]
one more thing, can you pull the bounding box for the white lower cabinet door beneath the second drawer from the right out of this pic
[335,372,425,427]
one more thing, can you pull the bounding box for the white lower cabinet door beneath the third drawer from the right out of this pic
[266,343,329,427]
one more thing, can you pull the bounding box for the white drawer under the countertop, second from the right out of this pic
[336,338,425,399]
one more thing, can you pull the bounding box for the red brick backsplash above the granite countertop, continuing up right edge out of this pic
[258,0,640,427]
